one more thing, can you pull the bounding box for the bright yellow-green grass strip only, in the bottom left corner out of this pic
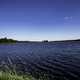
[0,71,36,80]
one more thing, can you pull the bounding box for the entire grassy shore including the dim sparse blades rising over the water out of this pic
[0,65,50,80]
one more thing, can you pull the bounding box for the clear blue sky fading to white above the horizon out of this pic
[0,0,80,41]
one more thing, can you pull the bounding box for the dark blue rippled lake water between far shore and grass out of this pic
[0,42,80,80]
